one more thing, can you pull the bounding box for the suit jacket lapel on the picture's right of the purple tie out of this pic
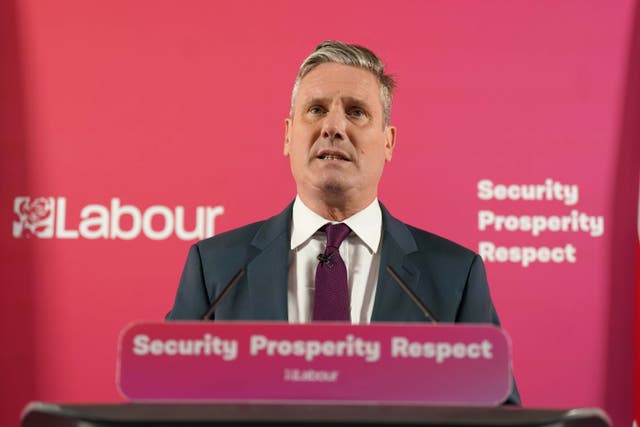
[371,205,428,322]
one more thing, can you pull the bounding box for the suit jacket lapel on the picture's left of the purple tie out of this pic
[247,205,292,320]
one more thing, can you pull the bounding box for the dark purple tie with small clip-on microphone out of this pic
[313,224,351,321]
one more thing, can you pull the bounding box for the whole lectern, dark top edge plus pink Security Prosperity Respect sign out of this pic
[22,322,610,427]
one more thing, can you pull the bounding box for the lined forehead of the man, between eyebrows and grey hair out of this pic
[296,63,381,108]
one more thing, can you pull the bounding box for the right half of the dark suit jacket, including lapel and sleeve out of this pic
[374,207,499,324]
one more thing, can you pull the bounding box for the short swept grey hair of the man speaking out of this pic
[289,40,396,126]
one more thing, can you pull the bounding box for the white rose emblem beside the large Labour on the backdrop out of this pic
[13,197,55,238]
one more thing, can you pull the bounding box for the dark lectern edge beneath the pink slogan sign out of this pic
[22,402,610,427]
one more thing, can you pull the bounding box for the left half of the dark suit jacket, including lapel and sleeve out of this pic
[167,205,291,320]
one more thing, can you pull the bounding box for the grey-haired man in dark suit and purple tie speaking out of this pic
[167,42,520,403]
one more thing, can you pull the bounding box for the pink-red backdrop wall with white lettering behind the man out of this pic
[0,0,640,425]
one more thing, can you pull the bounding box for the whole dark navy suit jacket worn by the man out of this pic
[167,204,520,404]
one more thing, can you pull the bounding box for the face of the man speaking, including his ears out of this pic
[284,63,396,209]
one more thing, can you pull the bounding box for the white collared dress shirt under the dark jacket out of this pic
[288,197,382,324]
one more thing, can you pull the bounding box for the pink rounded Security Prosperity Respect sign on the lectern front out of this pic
[117,322,511,405]
